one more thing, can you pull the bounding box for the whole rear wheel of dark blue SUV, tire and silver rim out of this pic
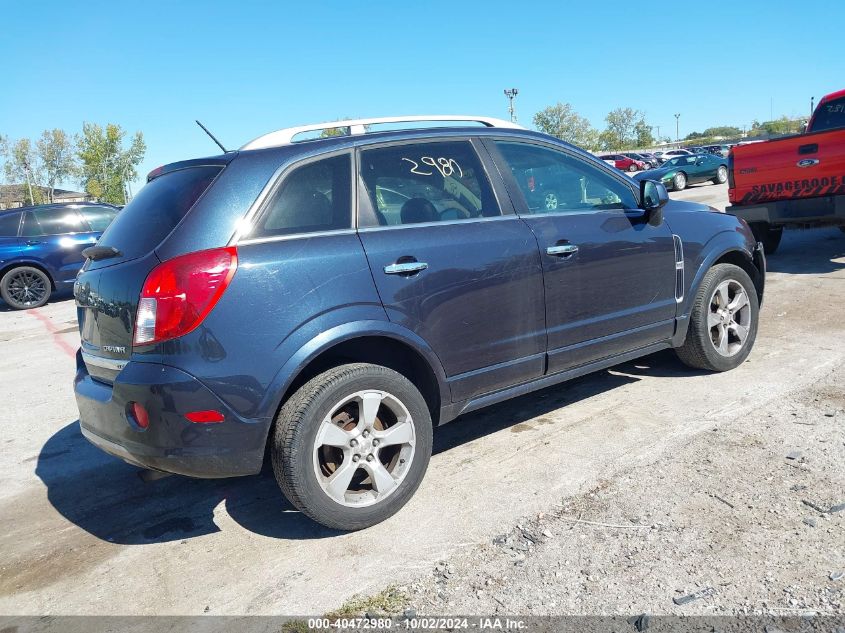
[271,363,432,530]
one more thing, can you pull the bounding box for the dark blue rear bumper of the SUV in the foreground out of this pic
[74,353,270,478]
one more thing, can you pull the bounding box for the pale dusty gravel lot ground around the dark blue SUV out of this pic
[0,185,845,615]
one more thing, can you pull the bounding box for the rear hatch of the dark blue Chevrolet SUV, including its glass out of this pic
[74,157,226,383]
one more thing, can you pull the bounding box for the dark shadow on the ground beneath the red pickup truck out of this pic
[766,227,845,275]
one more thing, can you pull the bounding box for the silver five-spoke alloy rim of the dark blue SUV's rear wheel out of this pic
[314,390,416,507]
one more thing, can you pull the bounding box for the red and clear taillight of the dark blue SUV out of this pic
[134,246,238,345]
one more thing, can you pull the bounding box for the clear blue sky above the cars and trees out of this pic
[0,0,845,191]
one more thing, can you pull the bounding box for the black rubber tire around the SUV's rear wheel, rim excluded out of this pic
[271,363,432,530]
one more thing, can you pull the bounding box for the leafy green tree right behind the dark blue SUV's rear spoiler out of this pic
[77,123,147,204]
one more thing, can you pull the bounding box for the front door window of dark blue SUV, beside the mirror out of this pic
[496,141,637,213]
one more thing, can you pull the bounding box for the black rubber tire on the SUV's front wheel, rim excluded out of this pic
[675,264,759,371]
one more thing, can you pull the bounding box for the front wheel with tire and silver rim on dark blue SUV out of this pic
[675,264,759,371]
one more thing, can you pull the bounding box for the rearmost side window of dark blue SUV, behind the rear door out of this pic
[254,154,352,237]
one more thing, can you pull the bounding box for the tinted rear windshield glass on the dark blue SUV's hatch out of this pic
[99,166,222,259]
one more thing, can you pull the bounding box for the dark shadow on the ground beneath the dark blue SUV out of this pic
[35,354,691,545]
